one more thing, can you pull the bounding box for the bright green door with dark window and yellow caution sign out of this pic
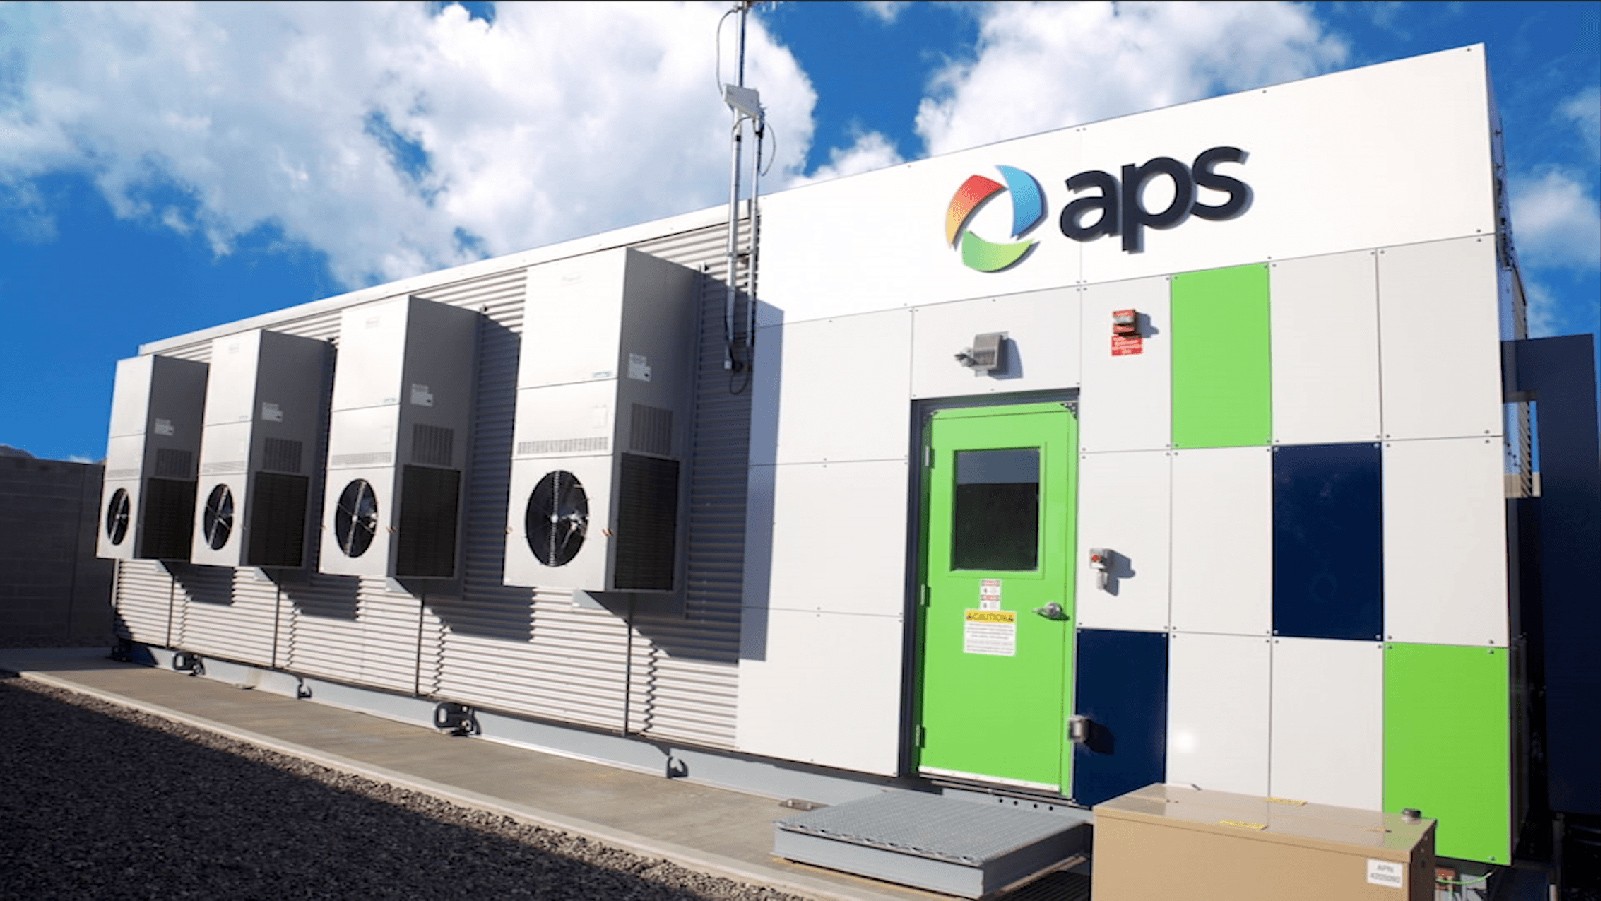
[917,403,1077,792]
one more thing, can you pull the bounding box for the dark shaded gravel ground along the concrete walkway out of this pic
[0,674,801,901]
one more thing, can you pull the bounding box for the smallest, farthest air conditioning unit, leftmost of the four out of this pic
[96,355,207,560]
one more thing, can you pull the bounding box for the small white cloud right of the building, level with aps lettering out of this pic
[1511,168,1601,269]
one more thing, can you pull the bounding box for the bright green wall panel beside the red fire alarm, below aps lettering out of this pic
[1172,264,1273,448]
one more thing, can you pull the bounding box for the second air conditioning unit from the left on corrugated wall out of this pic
[189,330,328,570]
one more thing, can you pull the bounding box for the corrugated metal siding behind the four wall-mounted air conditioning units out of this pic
[118,227,749,747]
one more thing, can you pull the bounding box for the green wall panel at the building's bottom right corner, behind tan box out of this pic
[1385,643,1511,864]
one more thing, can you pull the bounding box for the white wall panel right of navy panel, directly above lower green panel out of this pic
[1383,438,1508,647]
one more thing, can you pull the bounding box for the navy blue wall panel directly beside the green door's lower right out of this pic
[1073,629,1167,805]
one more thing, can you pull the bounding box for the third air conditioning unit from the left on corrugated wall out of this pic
[319,298,479,579]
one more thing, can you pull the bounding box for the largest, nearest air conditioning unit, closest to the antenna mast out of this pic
[504,250,698,605]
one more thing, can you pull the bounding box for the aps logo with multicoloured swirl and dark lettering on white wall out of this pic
[945,147,1252,272]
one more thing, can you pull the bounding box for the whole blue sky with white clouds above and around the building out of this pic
[0,2,1601,459]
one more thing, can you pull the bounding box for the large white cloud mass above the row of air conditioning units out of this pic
[0,3,815,285]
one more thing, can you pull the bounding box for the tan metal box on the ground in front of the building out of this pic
[1090,784,1434,901]
